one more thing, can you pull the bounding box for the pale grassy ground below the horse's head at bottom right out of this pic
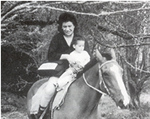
[99,96,150,119]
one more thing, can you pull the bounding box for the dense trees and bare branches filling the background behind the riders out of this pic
[1,1,150,103]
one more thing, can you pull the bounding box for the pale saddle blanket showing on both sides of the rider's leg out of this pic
[30,79,75,114]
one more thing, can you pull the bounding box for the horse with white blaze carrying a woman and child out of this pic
[27,50,130,119]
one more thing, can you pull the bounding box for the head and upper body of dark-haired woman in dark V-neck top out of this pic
[48,13,90,77]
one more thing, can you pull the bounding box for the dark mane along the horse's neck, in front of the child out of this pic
[77,58,97,79]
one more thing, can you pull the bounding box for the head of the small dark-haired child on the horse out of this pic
[73,36,85,53]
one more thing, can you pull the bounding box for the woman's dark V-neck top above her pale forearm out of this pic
[48,33,90,62]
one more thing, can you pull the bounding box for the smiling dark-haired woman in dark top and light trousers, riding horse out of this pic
[31,13,90,117]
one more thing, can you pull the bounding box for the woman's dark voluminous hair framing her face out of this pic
[58,12,77,33]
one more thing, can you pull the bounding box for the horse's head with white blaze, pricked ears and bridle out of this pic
[96,49,130,108]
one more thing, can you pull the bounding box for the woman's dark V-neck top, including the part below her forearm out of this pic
[48,33,90,77]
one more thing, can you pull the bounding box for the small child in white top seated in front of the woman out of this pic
[57,37,90,90]
